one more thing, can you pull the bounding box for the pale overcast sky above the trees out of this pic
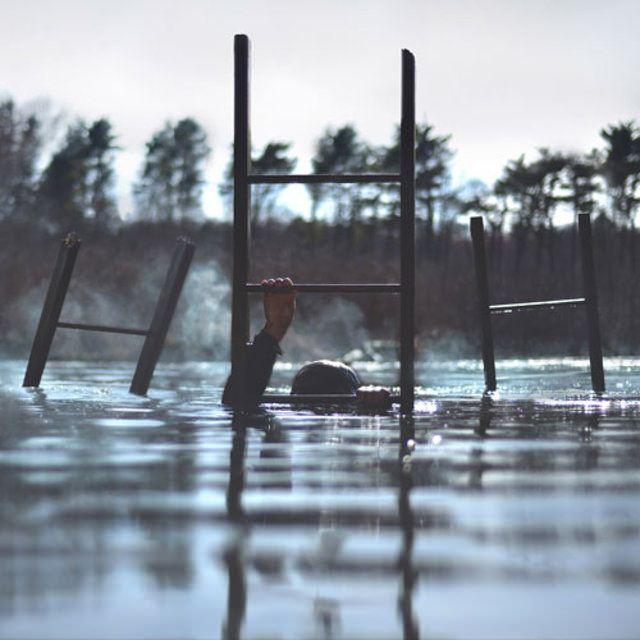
[0,0,640,215]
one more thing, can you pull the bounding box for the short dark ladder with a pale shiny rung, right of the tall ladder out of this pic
[470,213,604,392]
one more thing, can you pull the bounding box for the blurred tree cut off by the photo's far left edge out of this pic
[0,100,42,219]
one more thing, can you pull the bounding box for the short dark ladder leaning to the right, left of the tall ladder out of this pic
[22,234,195,395]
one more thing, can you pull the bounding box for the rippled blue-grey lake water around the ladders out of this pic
[0,359,640,640]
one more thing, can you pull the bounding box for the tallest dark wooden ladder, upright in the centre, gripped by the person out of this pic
[231,35,415,412]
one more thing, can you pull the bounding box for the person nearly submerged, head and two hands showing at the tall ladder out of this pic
[222,278,391,413]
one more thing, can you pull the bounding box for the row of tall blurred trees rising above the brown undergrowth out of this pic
[0,99,640,238]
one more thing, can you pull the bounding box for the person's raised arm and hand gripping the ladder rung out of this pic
[222,278,296,407]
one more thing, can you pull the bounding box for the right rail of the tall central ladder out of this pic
[400,49,416,413]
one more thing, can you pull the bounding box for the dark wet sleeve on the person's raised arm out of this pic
[222,331,282,407]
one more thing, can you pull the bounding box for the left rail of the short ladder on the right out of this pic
[471,216,497,391]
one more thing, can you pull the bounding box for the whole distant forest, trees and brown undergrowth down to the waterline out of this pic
[0,99,640,358]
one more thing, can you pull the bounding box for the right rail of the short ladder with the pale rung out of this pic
[578,213,605,393]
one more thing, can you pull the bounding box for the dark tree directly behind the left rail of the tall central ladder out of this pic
[218,141,297,225]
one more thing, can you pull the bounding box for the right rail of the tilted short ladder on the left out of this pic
[129,238,195,396]
